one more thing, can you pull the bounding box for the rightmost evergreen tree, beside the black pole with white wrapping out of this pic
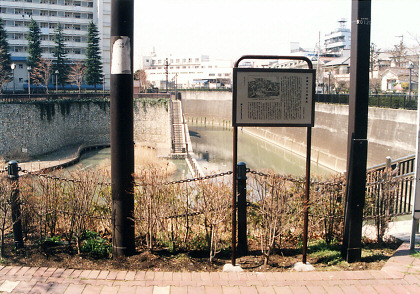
[85,21,104,91]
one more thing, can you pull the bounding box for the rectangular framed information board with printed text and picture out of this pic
[233,68,315,126]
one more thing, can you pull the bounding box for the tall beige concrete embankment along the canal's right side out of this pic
[182,91,417,172]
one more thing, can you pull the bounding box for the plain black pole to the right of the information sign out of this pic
[341,0,371,262]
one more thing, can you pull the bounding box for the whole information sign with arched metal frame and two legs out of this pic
[232,55,315,265]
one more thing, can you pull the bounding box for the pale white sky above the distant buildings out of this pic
[134,0,420,69]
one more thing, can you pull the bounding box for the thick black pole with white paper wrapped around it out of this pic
[110,0,135,258]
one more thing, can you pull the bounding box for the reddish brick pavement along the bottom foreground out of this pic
[0,243,420,294]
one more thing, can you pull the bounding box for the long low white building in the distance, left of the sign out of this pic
[142,53,233,89]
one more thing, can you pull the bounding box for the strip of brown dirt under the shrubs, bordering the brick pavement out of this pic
[1,240,400,272]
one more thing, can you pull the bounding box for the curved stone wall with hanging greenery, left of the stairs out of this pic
[0,100,170,158]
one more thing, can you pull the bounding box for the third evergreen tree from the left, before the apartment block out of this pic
[53,23,69,89]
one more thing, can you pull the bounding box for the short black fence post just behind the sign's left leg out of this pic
[236,162,248,255]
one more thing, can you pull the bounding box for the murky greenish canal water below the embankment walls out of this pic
[74,124,333,179]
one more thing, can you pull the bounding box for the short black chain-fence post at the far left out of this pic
[7,161,24,249]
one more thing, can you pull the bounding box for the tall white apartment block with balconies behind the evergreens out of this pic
[0,0,111,91]
